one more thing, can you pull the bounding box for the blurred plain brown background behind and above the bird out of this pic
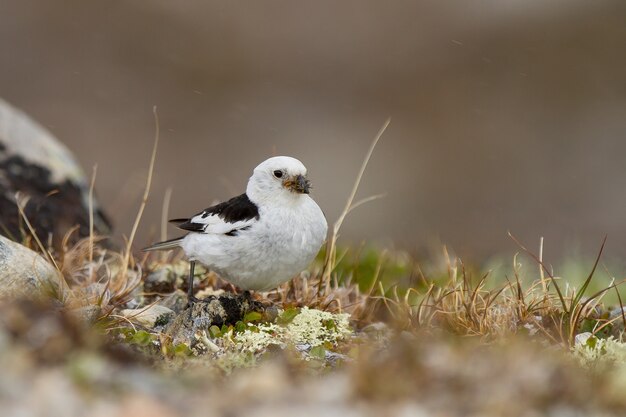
[0,0,626,258]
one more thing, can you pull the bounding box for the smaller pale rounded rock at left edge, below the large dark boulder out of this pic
[0,236,60,298]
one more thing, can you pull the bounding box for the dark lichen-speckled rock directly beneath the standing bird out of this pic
[165,293,264,346]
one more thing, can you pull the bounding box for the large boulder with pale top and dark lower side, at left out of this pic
[0,99,110,247]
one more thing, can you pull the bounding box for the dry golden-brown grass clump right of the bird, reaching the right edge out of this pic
[372,239,624,348]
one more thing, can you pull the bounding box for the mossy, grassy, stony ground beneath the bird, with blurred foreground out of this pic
[0,234,626,416]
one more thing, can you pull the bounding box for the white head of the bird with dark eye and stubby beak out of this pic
[247,156,311,201]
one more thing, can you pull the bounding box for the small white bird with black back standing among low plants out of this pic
[143,156,328,305]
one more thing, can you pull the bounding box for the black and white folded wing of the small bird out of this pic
[170,193,259,236]
